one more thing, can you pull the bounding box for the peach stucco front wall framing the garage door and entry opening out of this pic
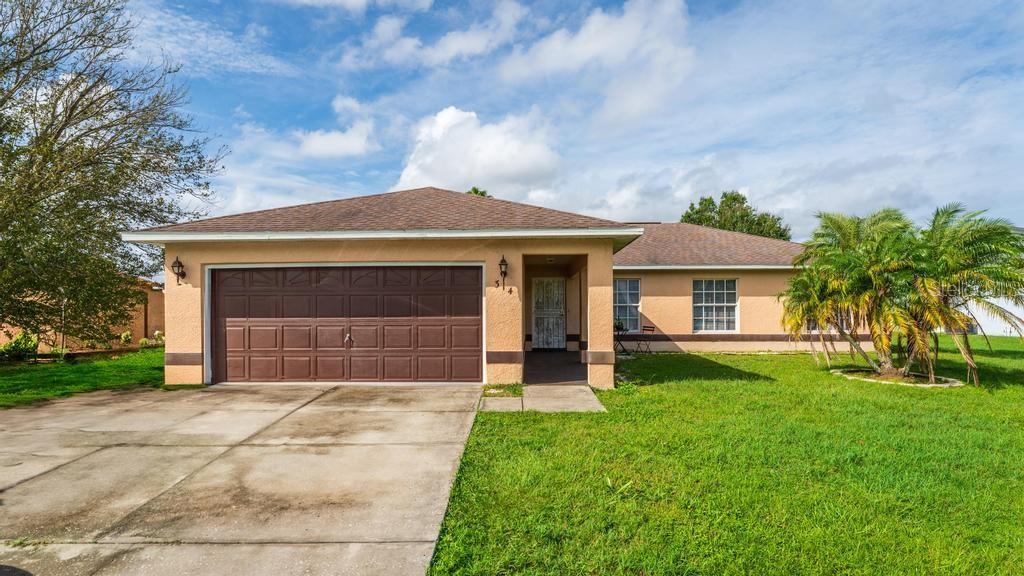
[159,239,613,387]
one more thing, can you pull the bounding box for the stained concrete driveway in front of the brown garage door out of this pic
[0,385,480,576]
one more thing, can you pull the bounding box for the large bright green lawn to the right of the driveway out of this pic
[431,338,1024,575]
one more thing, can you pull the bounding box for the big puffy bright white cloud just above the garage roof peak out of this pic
[394,107,561,198]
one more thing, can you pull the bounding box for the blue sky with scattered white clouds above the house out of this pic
[130,0,1024,238]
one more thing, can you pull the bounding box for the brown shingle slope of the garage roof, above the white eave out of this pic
[141,188,626,233]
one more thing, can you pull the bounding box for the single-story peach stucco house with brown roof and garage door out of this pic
[124,188,815,387]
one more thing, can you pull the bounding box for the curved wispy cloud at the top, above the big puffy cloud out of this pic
[341,0,527,69]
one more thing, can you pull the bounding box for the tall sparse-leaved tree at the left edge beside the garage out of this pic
[0,0,220,340]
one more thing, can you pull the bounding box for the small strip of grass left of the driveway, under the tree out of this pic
[0,347,164,408]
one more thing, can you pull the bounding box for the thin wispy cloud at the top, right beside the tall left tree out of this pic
[128,0,296,76]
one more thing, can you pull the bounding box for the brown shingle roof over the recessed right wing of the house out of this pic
[614,222,804,270]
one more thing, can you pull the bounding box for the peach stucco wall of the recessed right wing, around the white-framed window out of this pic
[614,270,839,352]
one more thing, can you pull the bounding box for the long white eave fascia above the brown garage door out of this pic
[121,227,643,246]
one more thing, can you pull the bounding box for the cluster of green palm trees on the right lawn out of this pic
[780,204,1024,383]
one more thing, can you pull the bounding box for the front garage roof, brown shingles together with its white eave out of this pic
[124,188,640,242]
